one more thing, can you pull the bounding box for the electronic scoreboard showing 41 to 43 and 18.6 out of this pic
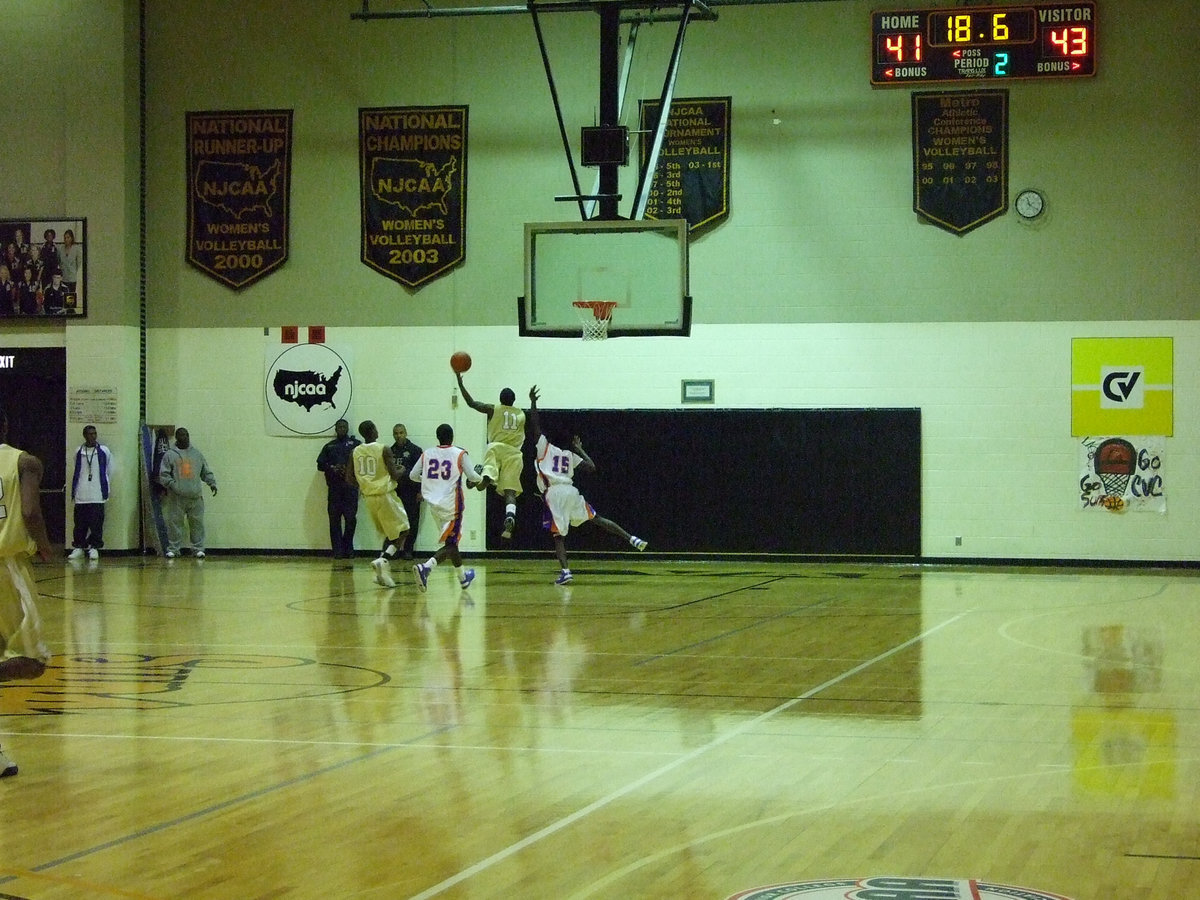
[871,1,1096,85]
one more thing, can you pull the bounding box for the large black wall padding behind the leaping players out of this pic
[487,409,920,558]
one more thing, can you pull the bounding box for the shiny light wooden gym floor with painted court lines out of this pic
[0,553,1200,900]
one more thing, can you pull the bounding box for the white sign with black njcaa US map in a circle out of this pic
[266,343,354,434]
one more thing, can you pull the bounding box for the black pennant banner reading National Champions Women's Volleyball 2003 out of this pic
[359,106,467,288]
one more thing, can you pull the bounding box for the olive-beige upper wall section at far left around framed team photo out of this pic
[0,0,138,332]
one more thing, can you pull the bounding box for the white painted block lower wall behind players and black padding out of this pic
[149,322,1200,560]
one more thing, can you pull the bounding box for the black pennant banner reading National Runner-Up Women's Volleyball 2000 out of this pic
[187,109,292,290]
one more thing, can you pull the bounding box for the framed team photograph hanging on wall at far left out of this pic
[0,216,88,319]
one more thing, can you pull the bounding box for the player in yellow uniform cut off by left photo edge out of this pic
[0,407,54,778]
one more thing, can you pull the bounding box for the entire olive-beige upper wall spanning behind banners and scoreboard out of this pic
[0,0,1166,326]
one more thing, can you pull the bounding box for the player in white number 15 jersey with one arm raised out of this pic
[529,385,646,584]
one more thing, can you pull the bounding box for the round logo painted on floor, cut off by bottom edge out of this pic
[728,876,1070,900]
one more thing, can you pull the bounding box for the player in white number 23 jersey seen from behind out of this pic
[408,424,481,592]
